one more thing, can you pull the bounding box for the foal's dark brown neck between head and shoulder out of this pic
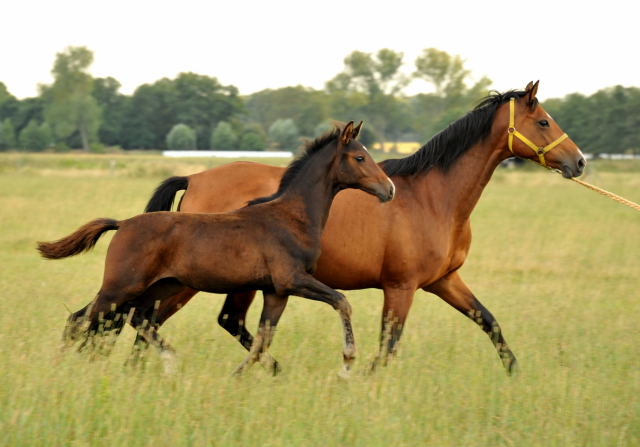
[280,150,339,238]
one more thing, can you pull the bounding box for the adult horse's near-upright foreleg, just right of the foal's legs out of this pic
[371,286,415,370]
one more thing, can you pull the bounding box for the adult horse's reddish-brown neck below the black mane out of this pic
[427,133,508,224]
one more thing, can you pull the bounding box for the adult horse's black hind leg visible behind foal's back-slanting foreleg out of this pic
[218,290,281,375]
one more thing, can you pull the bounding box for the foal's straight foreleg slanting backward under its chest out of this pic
[234,292,288,375]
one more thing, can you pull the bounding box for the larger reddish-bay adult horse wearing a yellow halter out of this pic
[146,82,585,372]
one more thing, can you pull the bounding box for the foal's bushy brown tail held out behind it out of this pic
[38,218,120,259]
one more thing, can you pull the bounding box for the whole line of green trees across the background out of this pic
[0,47,640,153]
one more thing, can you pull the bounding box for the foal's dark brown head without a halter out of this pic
[329,121,396,202]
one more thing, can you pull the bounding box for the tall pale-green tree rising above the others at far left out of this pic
[42,47,101,151]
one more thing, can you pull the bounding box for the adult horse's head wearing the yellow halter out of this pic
[500,82,586,178]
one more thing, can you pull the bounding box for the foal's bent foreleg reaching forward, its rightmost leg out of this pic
[291,274,356,376]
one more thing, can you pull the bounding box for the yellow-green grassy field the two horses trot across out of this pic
[0,154,640,446]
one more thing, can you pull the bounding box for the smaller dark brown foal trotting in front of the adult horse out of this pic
[38,122,395,371]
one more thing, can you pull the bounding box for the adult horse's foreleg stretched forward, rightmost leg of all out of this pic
[425,272,517,375]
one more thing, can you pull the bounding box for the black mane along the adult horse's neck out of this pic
[382,90,526,176]
